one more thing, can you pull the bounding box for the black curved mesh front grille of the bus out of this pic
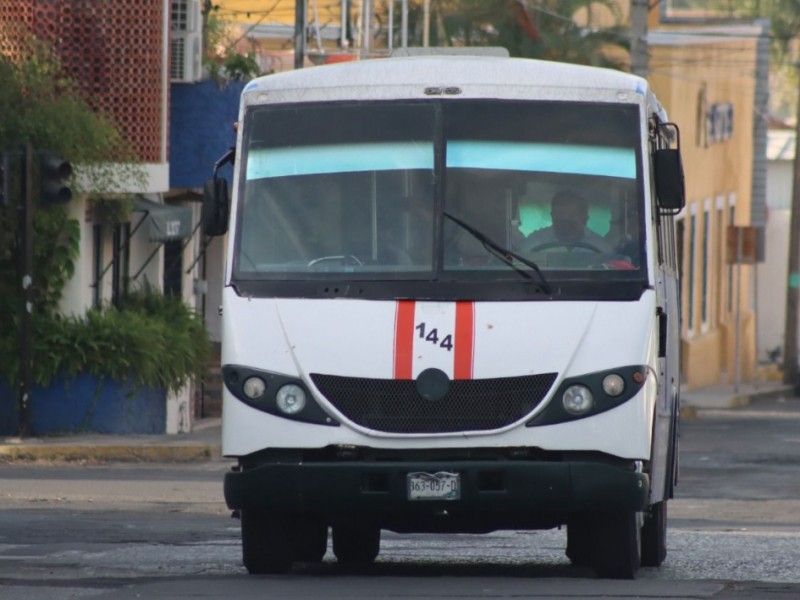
[311,373,556,433]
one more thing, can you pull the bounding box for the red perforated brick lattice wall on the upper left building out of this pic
[0,0,169,162]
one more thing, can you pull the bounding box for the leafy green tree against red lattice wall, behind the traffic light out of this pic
[0,25,143,324]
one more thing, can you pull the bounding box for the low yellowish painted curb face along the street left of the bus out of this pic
[0,443,221,462]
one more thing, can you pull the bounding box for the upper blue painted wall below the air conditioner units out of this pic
[169,80,246,188]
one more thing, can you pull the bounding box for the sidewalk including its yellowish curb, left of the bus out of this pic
[0,419,221,463]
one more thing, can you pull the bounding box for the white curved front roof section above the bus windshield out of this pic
[245,55,649,103]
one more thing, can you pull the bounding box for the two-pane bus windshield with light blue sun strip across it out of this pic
[233,100,645,292]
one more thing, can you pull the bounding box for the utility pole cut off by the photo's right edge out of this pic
[783,65,800,389]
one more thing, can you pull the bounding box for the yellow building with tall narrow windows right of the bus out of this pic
[647,14,768,388]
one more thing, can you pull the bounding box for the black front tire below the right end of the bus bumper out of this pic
[592,510,641,579]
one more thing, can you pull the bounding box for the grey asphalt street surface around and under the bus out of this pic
[0,400,800,600]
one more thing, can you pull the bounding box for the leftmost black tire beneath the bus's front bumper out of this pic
[242,509,294,575]
